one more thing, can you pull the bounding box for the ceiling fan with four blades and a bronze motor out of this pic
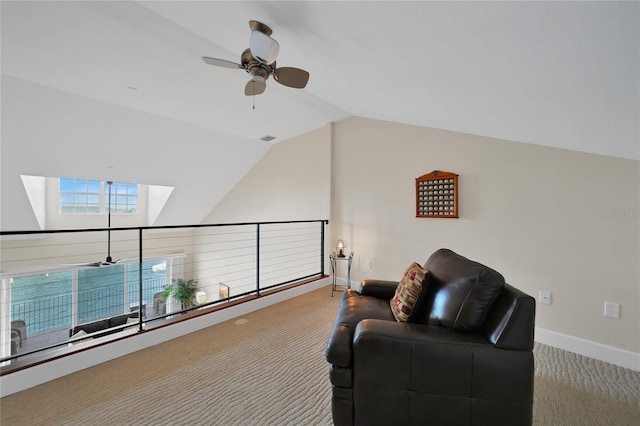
[202,20,309,96]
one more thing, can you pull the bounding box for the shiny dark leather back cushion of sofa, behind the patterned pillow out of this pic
[419,249,505,332]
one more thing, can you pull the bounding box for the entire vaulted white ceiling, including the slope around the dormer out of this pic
[0,1,640,229]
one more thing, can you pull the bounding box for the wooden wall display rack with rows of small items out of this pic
[416,170,458,218]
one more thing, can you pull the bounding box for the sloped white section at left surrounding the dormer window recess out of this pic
[2,76,270,230]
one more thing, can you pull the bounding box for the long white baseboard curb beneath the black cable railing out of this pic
[0,278,331,398]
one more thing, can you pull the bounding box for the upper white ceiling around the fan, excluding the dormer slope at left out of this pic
[0,1,640,230]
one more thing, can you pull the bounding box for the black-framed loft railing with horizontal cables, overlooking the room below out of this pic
[0,220,328,364]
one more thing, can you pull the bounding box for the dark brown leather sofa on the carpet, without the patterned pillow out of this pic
[326,249,535,426]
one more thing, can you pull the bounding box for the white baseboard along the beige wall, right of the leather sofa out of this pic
[535,327,640,371]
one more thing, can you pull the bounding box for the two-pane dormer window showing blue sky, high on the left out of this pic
[60,178,138,214]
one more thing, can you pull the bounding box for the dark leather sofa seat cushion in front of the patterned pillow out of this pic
[325,290,396,367]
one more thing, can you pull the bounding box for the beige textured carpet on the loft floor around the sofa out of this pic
[0,288,640,426]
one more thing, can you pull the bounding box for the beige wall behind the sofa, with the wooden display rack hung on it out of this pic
[331,118,640,353]
